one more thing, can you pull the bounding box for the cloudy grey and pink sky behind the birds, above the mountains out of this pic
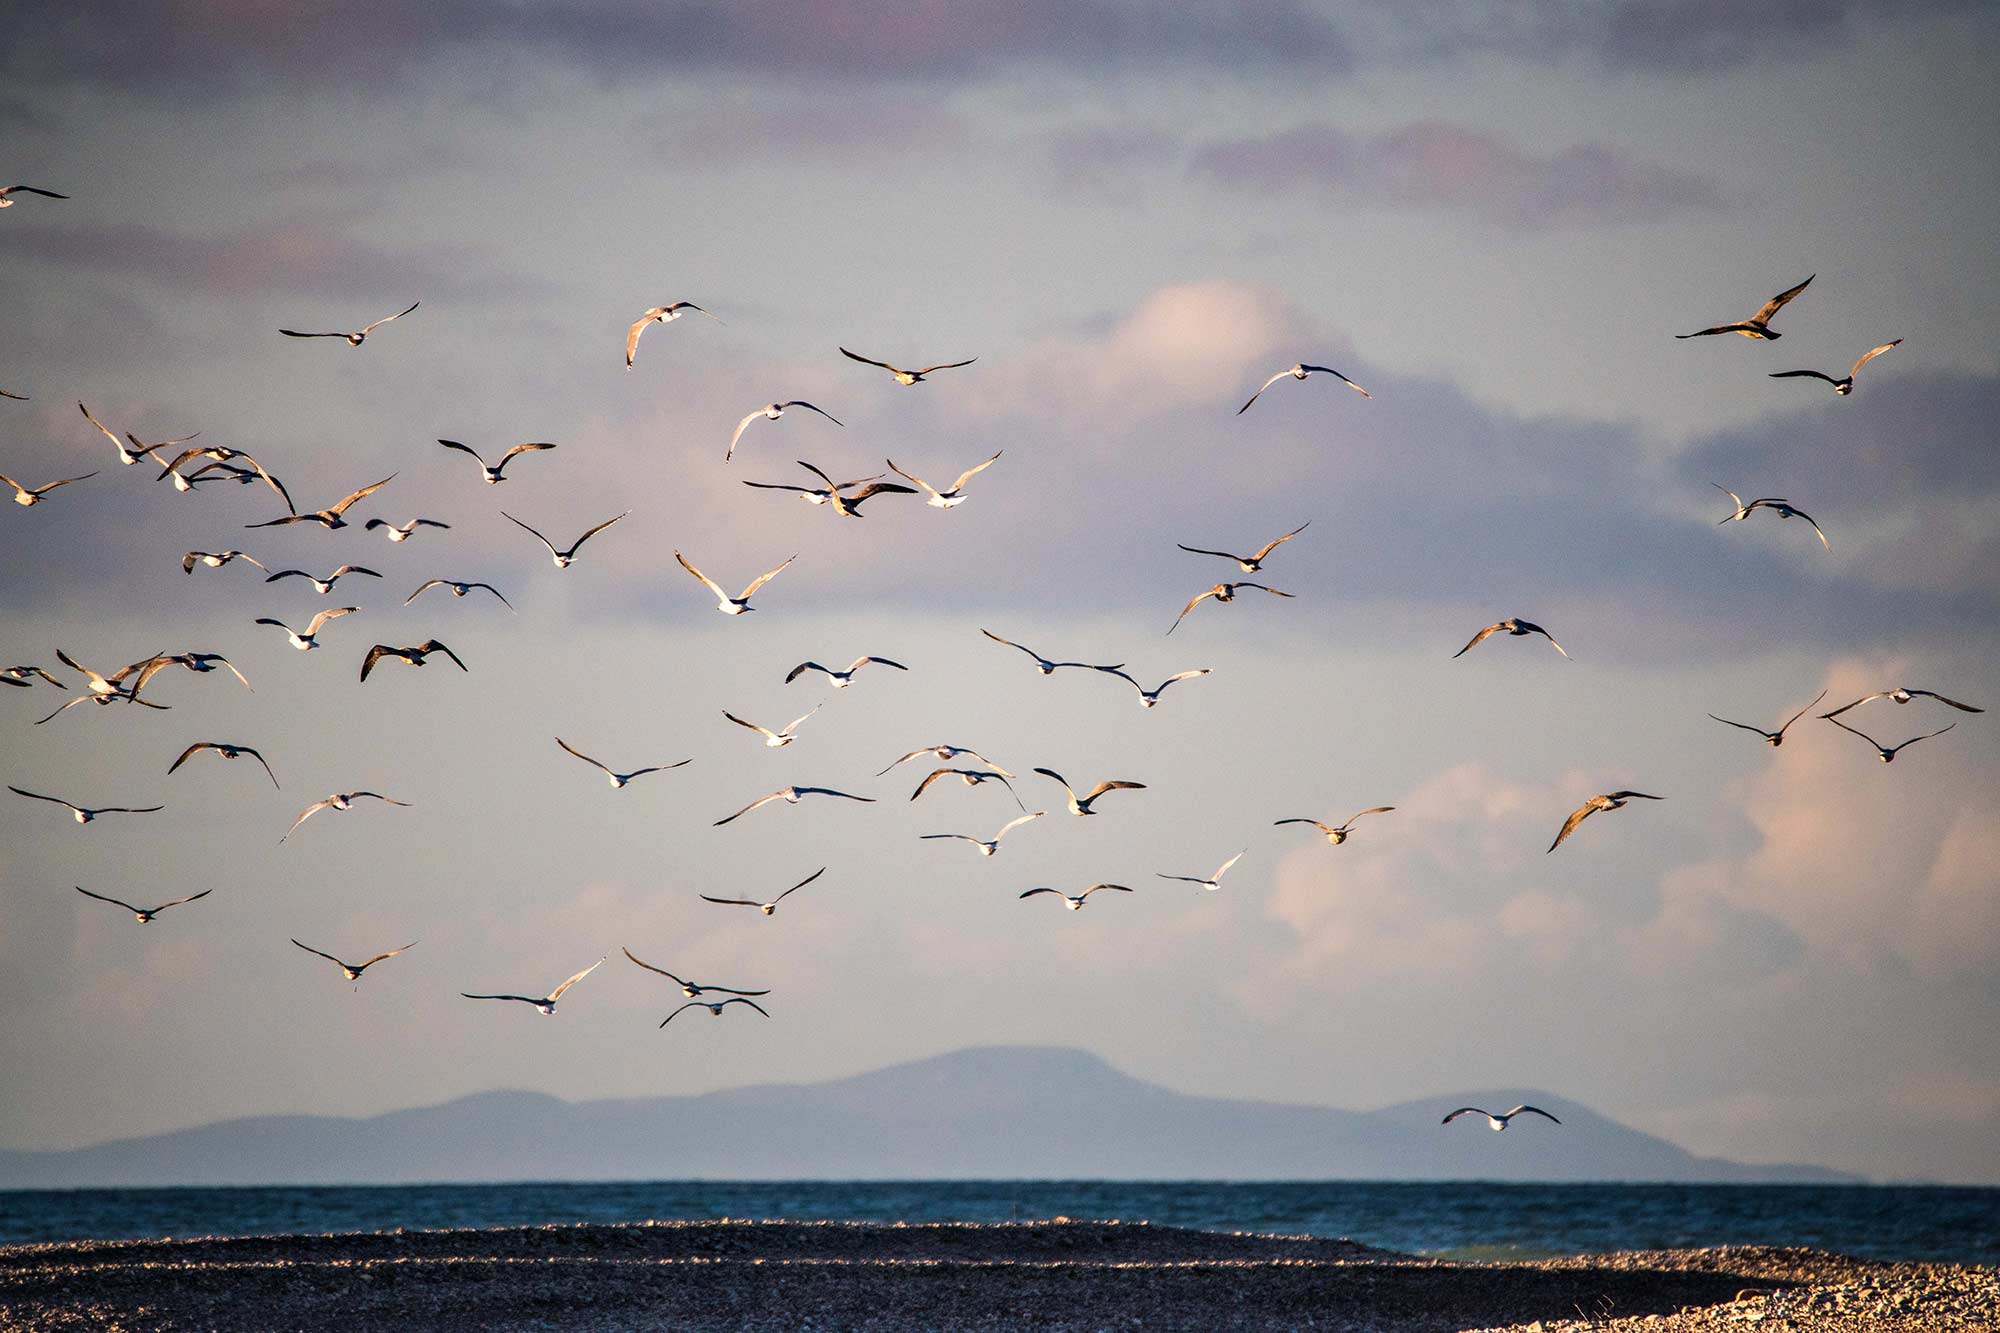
[0,0,2000,1183]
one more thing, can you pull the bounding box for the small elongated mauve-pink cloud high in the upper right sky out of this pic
[1188,120,1720,226]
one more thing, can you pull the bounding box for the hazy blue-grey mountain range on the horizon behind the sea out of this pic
[0,1047,1854,1189]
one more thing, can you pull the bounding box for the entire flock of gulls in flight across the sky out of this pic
[0,174,1982,1131]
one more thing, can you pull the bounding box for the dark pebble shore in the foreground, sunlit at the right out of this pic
[0,1219,2000,1333]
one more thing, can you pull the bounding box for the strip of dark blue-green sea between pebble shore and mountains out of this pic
[0,1181,2000,1265]
